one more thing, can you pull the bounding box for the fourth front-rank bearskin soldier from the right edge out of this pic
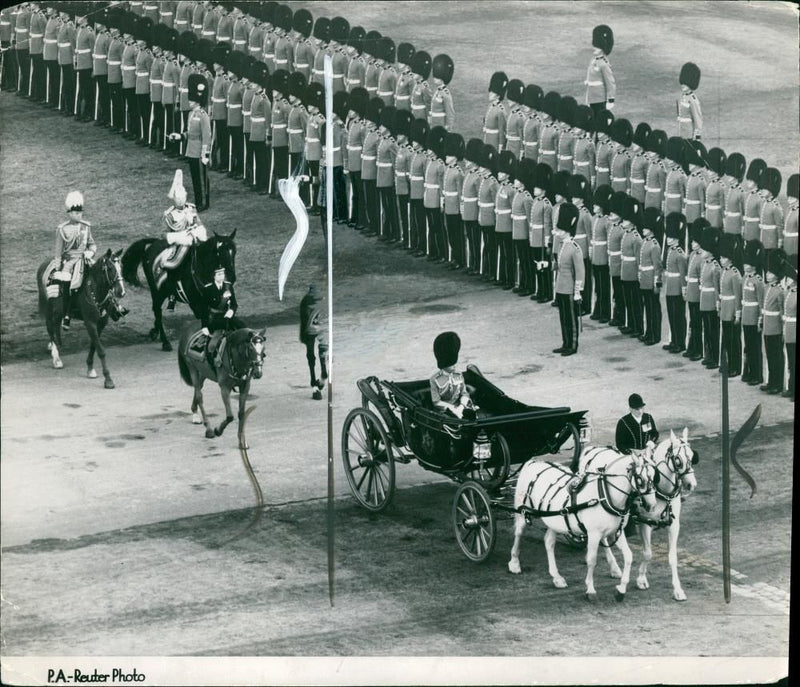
[719,234,743,377]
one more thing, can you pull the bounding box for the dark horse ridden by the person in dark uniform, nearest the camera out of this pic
[178,328,266,449]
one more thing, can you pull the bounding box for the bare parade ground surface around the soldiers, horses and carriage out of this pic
[0,2,800,683]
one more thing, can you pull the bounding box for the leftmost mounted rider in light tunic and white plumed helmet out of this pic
[50,191,97,329]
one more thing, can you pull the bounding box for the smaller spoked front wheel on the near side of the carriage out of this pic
[453,482,497,563]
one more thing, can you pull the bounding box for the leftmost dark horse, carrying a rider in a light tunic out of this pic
[36,250,126,389]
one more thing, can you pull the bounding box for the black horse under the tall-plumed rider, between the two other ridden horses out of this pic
[122,229,236,351]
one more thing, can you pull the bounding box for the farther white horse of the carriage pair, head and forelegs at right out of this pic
[632,427,698,601]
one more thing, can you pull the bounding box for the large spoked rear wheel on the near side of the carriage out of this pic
[342,408,394,513]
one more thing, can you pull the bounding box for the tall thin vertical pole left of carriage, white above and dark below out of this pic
[323,55,335,606]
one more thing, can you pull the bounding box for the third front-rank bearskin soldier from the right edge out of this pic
[740,239,766,386]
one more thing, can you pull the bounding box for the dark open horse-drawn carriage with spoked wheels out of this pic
[342,365,591,560]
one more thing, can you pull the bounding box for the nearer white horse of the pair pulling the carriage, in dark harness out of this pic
[508,448,655,601]
